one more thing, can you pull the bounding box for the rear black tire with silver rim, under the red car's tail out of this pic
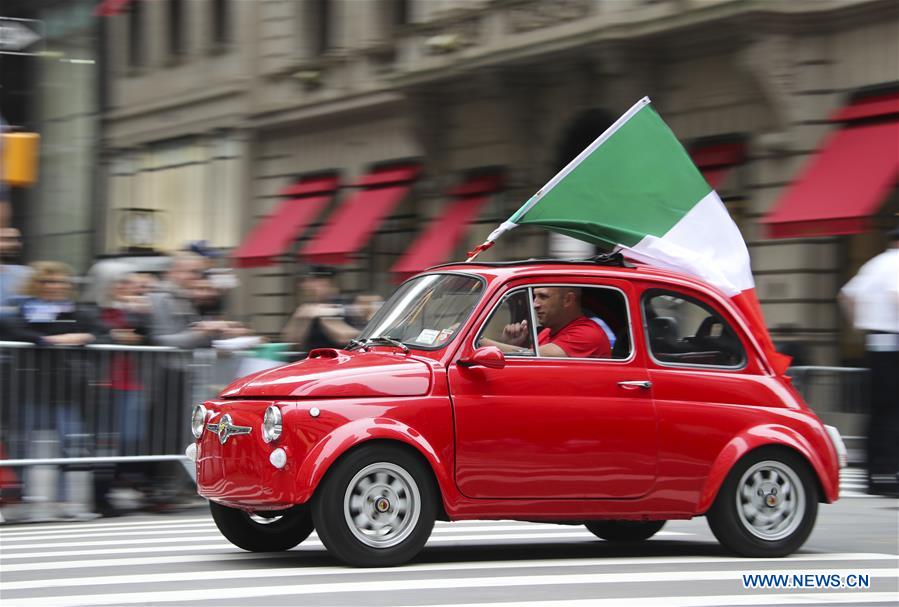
[706,447,818,557]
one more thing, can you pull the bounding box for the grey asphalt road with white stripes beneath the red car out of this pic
[0,472,899,607]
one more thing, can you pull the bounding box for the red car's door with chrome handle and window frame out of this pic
[448,280,657,499]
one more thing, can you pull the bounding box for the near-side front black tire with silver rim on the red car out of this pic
[312,445,437,567]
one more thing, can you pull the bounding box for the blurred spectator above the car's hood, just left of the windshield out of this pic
[281,266,359,352]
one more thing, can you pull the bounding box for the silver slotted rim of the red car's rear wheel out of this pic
[736,460,806,542]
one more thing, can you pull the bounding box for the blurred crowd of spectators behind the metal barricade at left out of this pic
[0,227,381,516]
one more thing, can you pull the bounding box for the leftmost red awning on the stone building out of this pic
[232,177,337,268]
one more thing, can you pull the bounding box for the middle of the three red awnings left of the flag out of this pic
[300,165,419,265]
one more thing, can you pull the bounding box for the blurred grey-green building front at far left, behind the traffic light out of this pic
[0,0,105,272]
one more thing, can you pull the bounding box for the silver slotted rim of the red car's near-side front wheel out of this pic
[343,462,421,548]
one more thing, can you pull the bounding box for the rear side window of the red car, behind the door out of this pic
[643,289,746,367]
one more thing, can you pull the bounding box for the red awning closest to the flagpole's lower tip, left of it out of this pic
[390,175,502,280]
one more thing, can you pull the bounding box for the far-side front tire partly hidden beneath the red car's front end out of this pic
[209,501,313,552]
